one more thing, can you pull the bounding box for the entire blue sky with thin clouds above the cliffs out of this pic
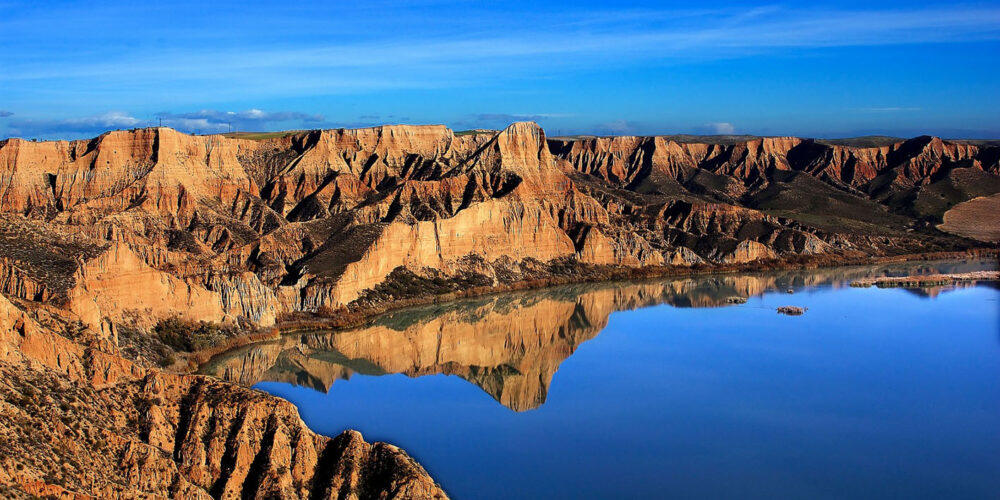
[0,0,1000,138]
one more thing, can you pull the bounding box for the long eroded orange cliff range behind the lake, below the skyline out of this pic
[0,122,1000,329]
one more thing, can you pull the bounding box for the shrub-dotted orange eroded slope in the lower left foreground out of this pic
[0,296,446,499]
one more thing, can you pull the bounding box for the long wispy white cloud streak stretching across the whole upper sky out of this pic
[0,7,1000,94]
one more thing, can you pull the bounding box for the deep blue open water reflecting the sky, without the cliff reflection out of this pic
[256,276,1000,498]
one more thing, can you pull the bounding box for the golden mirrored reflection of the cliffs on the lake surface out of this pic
[205,263,995,411]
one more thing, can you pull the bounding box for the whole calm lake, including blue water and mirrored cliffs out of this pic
[205,262,1000,499]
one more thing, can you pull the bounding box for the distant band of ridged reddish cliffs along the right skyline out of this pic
[550,137,1000,194]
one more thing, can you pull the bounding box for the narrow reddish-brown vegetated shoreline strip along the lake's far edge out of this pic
[180,247,1000,373]
